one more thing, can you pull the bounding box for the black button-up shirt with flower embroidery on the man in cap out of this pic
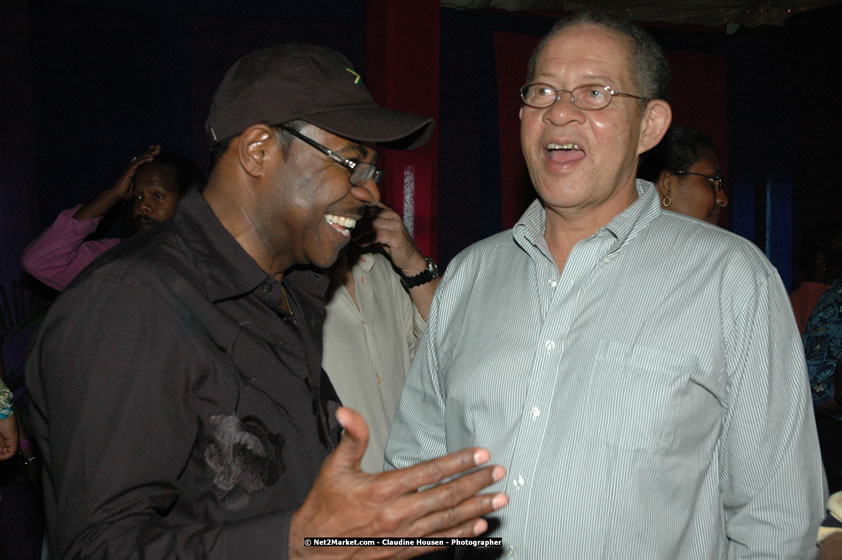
[27,192,336,559]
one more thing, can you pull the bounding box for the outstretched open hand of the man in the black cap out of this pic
[289,408,509,558]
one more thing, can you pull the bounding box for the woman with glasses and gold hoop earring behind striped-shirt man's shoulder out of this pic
[640,125,728,224]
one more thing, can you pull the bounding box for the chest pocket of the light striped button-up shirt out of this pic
[588,340,694,452]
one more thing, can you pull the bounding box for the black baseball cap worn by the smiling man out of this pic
[205,43,433,149]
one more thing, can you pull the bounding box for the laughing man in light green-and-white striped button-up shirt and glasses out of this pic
[386,10,826,560]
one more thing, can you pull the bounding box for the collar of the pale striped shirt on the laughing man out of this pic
[512,179,663,252]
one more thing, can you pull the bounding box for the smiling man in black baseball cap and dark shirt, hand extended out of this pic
[27,44,508,559]
